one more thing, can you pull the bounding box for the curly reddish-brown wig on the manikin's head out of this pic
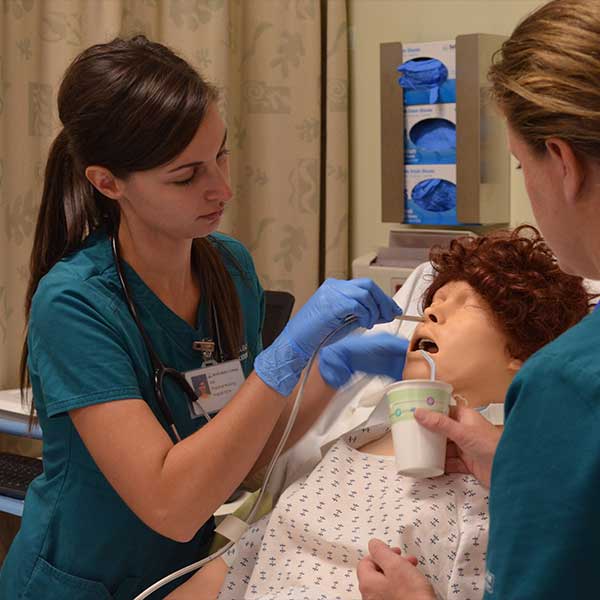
[423,225,592,360]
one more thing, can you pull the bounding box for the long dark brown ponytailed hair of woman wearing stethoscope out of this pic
[20,35,243,415]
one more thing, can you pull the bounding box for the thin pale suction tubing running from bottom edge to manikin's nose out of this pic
[134,314,424,600]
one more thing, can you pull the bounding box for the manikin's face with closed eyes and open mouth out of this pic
[404,281,521,407]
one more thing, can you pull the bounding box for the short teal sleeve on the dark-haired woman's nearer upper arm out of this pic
[28,282,142,416]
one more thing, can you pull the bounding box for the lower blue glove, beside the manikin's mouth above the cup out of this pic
[319,333,408,389]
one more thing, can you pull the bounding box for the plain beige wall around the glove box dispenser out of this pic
[349,0,542,258]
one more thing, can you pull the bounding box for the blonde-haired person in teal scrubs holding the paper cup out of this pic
[358,0,600,600]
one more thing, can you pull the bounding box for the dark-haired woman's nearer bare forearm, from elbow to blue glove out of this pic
[157,374,285,539]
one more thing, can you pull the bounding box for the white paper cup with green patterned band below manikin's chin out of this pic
[385,379,452,478]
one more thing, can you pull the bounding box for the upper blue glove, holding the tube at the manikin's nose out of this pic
[254,279,402,396]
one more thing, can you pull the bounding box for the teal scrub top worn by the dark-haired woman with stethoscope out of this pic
[0,232,264,600]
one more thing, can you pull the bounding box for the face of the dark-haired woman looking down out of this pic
[115,103,232,239]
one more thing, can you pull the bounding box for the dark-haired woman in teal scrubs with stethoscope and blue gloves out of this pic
[0,36,406,600]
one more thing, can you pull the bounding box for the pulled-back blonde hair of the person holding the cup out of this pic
[489,0,600,159]
